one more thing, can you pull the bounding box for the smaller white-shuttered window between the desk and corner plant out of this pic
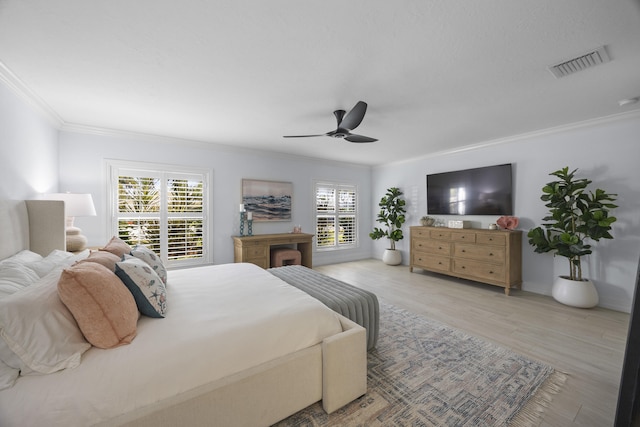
[315,182,358,250]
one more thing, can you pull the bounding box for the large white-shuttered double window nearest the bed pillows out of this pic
[108,162,210,267]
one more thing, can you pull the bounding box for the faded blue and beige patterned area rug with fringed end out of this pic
[276,303,565,427]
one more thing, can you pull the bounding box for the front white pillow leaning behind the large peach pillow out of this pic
[0,269,91,375]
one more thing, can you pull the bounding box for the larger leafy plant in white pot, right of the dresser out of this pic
[527,167,618,308]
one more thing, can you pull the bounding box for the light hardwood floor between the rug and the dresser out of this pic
[315,259,629,427]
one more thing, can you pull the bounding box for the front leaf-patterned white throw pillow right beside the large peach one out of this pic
[116,256,167,317]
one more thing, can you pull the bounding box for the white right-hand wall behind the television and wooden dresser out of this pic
[372,114,640,312]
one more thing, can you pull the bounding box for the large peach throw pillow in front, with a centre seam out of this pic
[58,262,139,348]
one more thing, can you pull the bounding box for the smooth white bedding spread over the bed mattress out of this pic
[0,264,342,427]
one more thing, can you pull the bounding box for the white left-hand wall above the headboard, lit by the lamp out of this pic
[0,82,58,199]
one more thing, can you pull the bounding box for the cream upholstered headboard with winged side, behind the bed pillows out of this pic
[0,200,66,259]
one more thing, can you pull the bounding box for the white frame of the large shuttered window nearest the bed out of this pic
[105,159,213,269]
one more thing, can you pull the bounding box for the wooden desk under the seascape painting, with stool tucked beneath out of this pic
[232,233,313,268]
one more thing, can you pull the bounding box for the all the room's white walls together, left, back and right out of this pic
[0,75,640,312]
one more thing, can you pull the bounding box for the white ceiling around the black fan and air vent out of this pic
[0,0,640,165]
